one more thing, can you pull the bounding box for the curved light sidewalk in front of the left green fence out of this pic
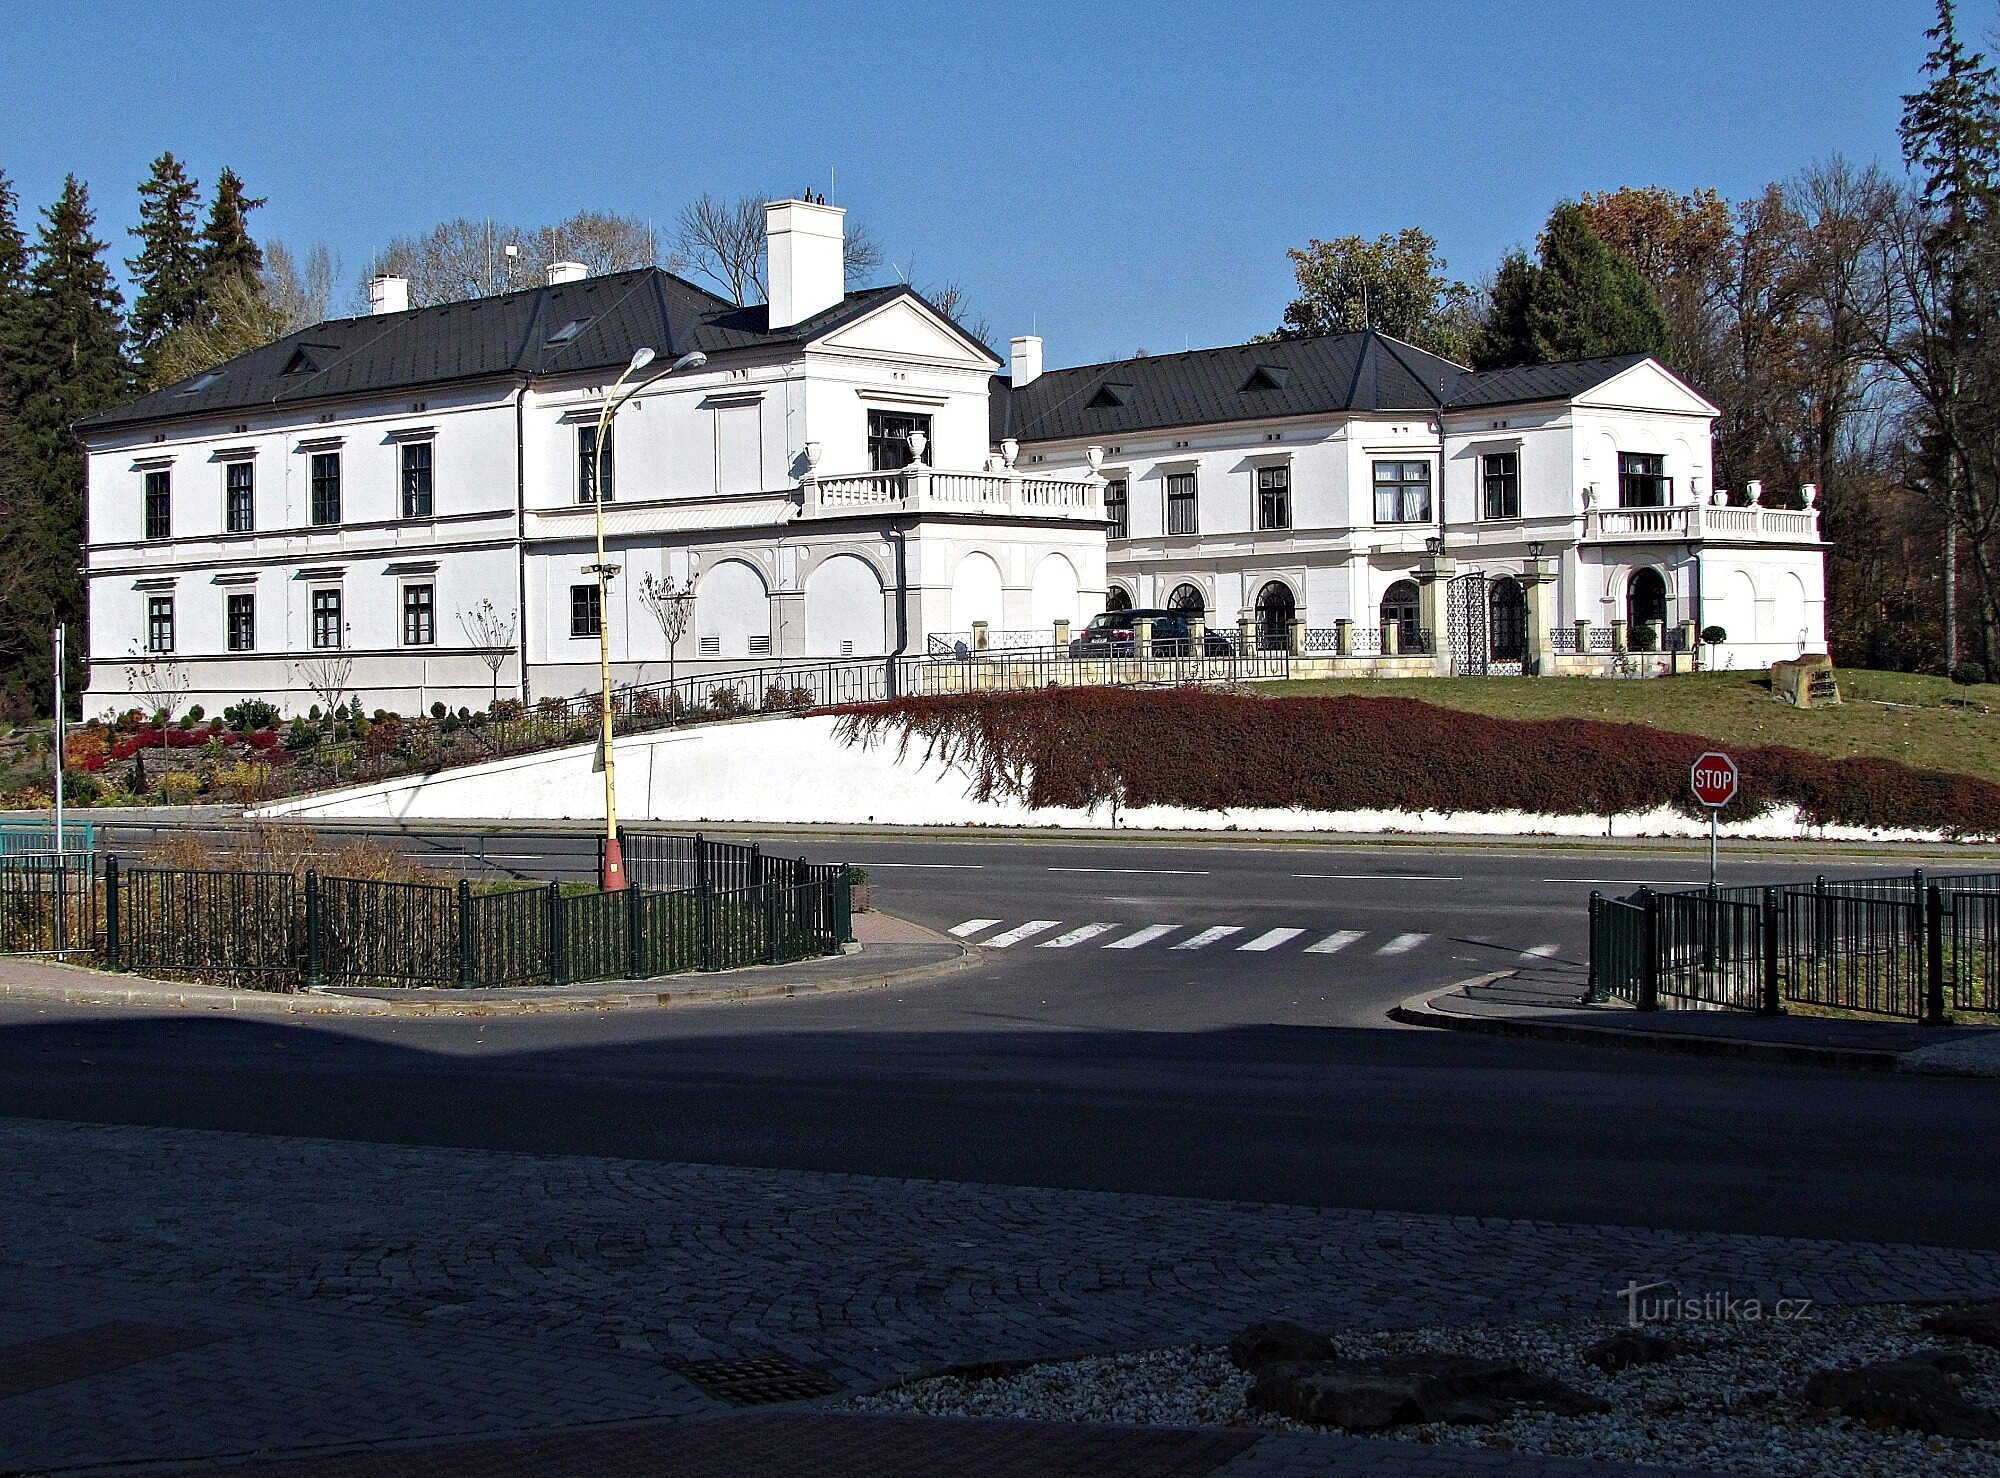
[0,912,978,1016]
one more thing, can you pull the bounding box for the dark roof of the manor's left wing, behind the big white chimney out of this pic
[78,268,916,430]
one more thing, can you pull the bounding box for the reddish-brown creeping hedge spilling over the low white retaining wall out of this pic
[836,688,2000,836]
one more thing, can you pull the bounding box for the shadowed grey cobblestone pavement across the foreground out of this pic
[0,1120,2000,1476]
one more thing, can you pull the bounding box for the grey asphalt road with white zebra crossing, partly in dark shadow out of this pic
[0,838,2000,1246]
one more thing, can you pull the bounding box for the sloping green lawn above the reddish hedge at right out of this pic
[1258,670,2000,782]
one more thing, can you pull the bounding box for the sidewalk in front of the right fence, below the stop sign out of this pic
[1390,968,2000,1078]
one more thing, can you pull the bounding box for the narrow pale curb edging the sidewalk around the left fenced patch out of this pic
[0,946,980,1020]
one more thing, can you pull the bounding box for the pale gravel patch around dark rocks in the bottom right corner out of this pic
[848,1304,2000,1478]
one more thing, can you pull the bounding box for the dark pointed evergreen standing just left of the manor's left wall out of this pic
[0,174,130,712]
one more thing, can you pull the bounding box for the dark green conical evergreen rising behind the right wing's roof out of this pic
[1528,200,1666,362]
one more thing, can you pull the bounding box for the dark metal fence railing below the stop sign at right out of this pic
[1590,870,2000,1024]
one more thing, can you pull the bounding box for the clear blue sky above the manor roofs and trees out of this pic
[0,0,1968,366]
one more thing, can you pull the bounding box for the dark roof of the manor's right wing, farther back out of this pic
[988,330,1672,442]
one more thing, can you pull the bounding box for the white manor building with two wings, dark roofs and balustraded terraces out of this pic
[78,200,1824,716]
